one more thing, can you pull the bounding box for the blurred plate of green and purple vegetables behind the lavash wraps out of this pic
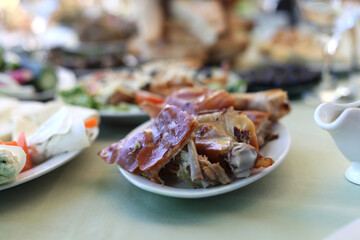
[0,50,76,101]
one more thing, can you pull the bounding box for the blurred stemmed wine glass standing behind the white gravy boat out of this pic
[297,0,360,104]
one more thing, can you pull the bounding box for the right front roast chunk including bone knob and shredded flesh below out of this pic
[172,110,273,187]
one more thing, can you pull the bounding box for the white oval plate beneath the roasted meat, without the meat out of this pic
[119,123,291,198]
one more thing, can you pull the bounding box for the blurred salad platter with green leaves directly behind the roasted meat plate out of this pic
[60,59,246,122]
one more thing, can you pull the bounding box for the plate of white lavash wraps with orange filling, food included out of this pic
[0,98,99,190]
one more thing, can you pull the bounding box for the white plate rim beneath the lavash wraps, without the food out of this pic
[0,129,99,191]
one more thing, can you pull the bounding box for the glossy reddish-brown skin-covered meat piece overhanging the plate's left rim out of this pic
[99,106,197,182]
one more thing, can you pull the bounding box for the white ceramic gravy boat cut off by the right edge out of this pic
[314,101,360,185]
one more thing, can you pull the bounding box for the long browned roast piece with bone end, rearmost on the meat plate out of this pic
[140,88,291,122]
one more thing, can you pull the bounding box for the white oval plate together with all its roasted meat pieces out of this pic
[99,88,290,198]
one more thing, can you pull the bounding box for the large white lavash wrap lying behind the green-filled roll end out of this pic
[13,103,99,163]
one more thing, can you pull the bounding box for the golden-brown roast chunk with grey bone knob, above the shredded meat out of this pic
[195,110,270,178]
